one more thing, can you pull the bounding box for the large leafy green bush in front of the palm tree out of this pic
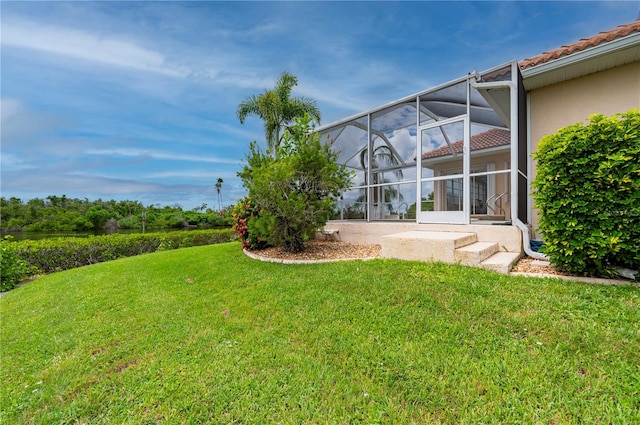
[238,114,351,252]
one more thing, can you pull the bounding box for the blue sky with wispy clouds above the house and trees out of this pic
[0,1,640,209]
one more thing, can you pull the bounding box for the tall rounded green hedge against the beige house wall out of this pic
[533,109,640,276]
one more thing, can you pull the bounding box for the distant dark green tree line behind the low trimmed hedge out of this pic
[0,195,231,232]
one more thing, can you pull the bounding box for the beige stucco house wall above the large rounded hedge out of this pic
[529,62,640,236]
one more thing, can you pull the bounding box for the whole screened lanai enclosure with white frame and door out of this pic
[318,63,527,224]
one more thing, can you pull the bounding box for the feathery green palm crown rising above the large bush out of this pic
[236,72,320,156]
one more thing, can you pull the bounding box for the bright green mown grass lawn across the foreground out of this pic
[0,243,640,424]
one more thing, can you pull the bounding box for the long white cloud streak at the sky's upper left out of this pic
[1,21,187,77]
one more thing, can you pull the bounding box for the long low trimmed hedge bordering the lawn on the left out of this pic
[1,229,234,281]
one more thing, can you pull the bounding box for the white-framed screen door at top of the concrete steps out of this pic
[416,115,470,224]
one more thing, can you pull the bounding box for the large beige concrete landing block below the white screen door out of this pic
[382,230,477,263]
